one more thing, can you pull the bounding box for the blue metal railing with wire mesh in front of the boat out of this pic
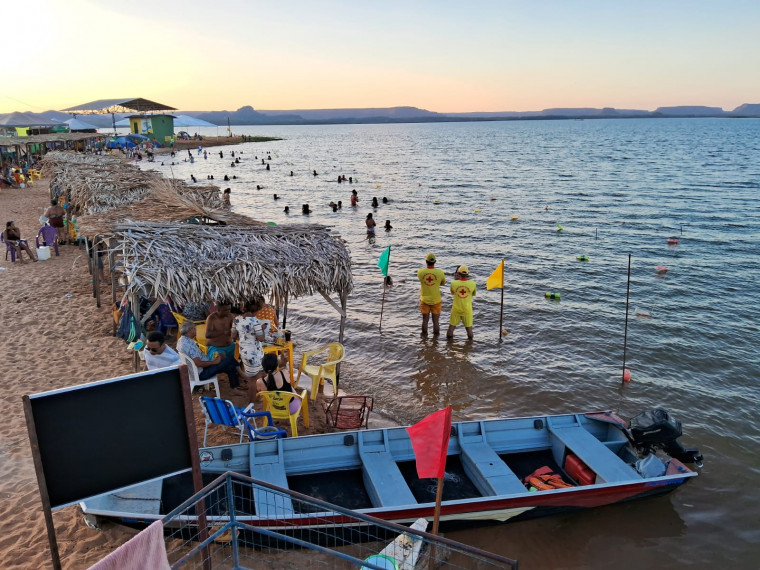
[163,472,517,570]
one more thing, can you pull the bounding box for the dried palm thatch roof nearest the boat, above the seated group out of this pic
[114,222,353,305]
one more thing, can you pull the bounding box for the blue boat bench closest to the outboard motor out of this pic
[549,426,641,483]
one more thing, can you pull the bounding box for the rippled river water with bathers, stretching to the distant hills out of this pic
[144,119,760,568]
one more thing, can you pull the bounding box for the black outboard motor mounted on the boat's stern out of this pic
[629,408,703,467]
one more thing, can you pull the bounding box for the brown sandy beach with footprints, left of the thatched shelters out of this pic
[0,177,344,569]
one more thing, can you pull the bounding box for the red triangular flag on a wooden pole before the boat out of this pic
[406,407,451,479]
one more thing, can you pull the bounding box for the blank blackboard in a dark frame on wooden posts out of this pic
[27,367,195,509]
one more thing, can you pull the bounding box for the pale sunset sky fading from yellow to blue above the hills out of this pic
[0,0,760,113]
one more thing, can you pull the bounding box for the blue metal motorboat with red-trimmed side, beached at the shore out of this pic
[82,413,697,532]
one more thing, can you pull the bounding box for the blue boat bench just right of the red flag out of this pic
[460,441,527,497]
